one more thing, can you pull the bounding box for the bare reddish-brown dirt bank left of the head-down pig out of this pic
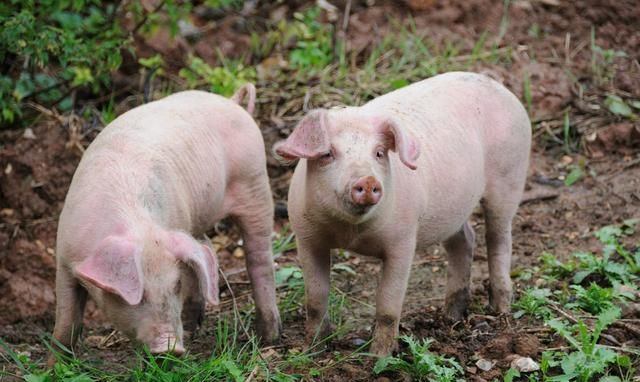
[0,124,80,325]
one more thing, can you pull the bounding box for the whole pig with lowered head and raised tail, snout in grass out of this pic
[51,85,280,362]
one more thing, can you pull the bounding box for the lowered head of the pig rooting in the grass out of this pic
[68,228,218,355]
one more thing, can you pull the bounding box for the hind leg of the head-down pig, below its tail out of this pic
[231,203,281,344]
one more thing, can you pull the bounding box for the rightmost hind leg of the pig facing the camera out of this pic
[482,176,524,313]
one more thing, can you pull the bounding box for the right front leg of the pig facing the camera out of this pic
[371,245,415,357]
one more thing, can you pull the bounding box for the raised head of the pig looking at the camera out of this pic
[274,108,420,224]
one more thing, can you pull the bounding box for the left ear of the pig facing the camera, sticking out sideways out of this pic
[273,109,331,163]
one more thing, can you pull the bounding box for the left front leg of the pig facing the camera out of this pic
[296,242,331,347]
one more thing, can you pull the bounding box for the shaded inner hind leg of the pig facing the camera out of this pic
[444,222,476,321]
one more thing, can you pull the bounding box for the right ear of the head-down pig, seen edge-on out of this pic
[171,232,220,305]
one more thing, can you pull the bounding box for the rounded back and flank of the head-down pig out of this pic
[59,91,265,254]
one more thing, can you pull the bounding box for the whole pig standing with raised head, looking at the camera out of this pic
[274,72,531,356]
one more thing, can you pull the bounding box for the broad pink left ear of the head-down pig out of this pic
[75,236,143,305]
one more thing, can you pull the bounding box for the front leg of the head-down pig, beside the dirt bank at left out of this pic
[48,264,87,366]
